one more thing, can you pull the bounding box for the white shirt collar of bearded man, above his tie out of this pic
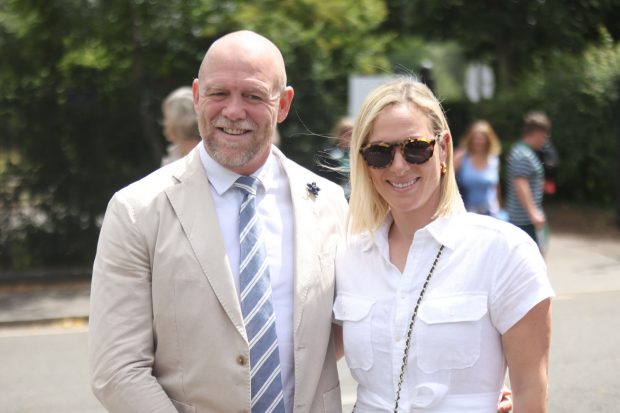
[199,144,276,195]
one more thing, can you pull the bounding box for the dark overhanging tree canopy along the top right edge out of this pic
[386,0,620,87]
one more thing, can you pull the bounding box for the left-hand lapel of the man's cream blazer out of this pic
[166,148,247,339]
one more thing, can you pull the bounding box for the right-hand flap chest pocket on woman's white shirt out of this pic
[414,293,487,373]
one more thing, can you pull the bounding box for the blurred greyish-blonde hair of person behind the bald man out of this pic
[161,86,200,141]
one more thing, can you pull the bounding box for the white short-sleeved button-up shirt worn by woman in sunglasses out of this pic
[334,210,553,413]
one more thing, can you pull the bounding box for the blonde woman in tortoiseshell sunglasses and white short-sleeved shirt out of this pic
[333,78,554,413]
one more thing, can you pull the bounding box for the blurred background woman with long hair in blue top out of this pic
[454,120,501,217]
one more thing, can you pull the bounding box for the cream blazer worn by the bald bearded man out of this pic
[89,148,347,413]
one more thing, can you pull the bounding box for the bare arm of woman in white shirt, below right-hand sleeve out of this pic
[502,298,551,413]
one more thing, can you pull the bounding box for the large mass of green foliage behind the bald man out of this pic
[0,0,390,270]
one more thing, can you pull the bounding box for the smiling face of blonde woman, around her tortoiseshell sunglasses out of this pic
[368,104,449,218]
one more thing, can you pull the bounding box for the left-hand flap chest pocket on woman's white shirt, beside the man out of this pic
[334,295,375,370]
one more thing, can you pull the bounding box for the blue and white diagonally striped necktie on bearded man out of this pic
[234,176,284,413]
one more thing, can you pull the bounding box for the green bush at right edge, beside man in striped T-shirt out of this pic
[542,35,620,204]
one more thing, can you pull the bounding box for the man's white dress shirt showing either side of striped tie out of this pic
[200,145,295,413]
